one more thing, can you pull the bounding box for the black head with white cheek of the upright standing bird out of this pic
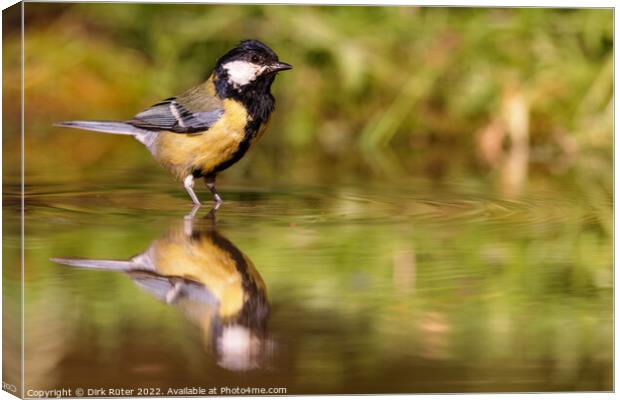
[215,40,293,97]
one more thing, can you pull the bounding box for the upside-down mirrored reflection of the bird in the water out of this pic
[52,210,273,371]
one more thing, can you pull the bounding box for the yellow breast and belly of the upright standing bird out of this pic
[152,99,248,179]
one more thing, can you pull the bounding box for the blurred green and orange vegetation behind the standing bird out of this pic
[5,3,613,195]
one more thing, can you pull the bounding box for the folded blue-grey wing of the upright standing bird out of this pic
[127,97,224,133]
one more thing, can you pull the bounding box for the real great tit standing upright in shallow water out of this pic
[55,39,293,206]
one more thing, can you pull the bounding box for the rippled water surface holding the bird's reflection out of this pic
[5,177,613,394]
